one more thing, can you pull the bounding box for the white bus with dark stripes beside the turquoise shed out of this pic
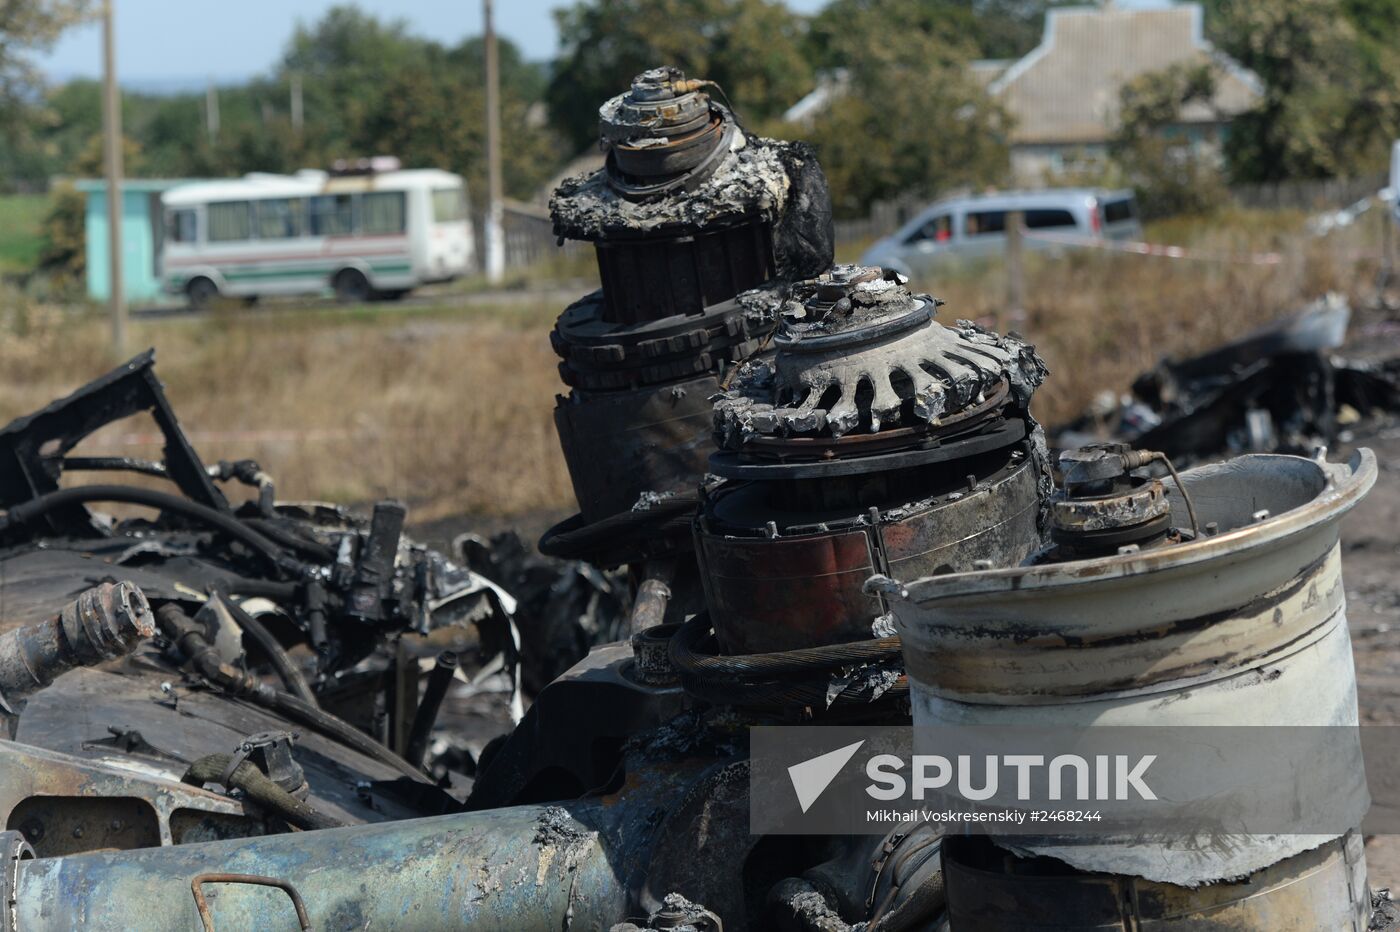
[161,168,473,308]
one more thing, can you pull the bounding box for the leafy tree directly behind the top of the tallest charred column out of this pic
[546,0,813,151]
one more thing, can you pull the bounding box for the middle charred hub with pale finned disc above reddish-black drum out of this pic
[696,266,1050,654]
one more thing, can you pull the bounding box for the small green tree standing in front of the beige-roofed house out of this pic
[1110,64,1228,218]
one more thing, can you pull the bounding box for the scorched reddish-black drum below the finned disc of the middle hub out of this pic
[696,449,1039,654]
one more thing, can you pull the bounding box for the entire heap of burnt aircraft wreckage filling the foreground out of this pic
[0,69,1376,932]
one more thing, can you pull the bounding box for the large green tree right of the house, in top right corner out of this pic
[1207,0,1400,182]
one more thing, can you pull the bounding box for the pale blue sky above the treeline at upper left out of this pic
[36,0,823,91]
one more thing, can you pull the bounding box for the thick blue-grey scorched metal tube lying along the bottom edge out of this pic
[10,768,694,932]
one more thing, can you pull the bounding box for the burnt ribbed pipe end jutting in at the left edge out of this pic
[0,582,155,704]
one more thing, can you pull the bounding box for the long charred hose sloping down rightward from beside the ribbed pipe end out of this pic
[155,602,431,782]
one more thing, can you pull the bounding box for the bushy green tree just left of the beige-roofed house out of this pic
[802,0,1008,216]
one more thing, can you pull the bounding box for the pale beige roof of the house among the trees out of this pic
[983,3,1263,144]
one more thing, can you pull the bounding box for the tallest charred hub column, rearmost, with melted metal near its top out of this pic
[542,69,833,545]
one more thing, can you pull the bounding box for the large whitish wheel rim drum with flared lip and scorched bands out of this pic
[886,449,1376,890]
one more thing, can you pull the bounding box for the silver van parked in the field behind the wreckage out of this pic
[861,188,1142,277]
